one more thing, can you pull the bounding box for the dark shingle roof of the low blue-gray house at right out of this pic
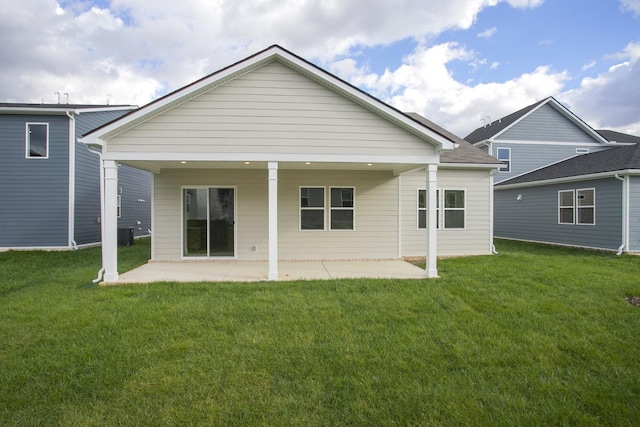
[496,144,640,187]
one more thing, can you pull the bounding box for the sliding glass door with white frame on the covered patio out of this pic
[182,187,235,257]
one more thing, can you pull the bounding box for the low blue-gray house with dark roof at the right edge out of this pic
[494,140,640,254]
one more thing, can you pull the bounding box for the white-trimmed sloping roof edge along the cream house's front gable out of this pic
[81,45,455,150]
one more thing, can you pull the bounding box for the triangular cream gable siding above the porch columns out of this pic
[107,62,435,158]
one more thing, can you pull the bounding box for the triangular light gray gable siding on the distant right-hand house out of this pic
[496,104,597,144]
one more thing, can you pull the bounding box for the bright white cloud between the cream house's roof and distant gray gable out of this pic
[352,43,568,136]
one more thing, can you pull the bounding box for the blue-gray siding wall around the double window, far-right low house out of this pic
[494,178,622,250]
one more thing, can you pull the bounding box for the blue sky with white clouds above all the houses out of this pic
[0,0,640,136]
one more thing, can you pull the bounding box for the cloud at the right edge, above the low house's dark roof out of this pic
[559,43,640,135]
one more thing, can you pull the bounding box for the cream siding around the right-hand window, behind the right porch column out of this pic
[401,167,492,256]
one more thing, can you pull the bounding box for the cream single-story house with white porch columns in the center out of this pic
[82,45,500,283]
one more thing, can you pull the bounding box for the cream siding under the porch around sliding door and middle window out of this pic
[152,169,398,260]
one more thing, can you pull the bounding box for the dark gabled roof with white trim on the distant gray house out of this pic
[464,96,607,144]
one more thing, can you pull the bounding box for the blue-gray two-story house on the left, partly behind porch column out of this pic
[0,103,151,250]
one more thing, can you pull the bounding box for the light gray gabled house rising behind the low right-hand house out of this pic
[464,97,624,184]
